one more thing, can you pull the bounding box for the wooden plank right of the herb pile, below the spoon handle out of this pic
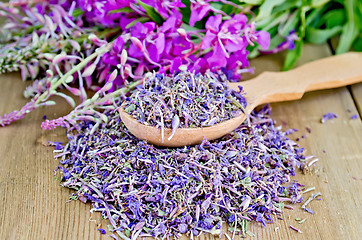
[272,88,362,239]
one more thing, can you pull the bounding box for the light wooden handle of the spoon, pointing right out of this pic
[230,52,362,108]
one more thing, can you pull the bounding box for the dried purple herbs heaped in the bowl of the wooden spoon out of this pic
[123,71,246,133]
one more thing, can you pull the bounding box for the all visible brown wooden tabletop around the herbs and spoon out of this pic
[0,45,362,239]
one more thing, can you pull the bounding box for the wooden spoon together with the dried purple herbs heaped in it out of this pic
[119,52,362,147]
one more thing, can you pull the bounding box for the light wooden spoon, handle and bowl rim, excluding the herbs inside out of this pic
[119,52,362,147]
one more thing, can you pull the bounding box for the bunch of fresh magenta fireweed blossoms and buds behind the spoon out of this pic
[0,1,269,125]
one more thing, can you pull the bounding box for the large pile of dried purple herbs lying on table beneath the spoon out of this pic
[56,99,308,239]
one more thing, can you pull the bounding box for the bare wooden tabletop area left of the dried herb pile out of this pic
[0,74,101,239]
